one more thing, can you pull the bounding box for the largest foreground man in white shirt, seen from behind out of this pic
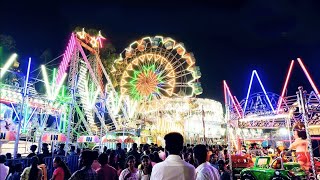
[151,132,195,180]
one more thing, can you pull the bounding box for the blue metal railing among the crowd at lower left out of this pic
[6,155,79,179]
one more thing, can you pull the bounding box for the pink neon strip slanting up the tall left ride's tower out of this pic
[56,33,75,84]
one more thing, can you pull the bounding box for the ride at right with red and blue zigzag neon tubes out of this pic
[223,58,320,177]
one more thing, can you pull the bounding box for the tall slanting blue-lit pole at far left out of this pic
[13,58,31,157]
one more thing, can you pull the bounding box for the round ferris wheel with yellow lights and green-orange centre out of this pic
[116,36,202,101]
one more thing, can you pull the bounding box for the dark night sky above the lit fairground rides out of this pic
[0,0,320,101]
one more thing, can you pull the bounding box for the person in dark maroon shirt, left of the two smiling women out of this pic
[97,153,118,180]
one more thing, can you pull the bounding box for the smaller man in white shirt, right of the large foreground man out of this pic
[193,144,220,180]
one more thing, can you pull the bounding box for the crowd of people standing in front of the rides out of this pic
[0,132,230,180]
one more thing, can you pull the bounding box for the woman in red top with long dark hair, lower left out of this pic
[51,157,71,180]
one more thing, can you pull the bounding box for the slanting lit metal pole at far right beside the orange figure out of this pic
[298,86,317,178]
